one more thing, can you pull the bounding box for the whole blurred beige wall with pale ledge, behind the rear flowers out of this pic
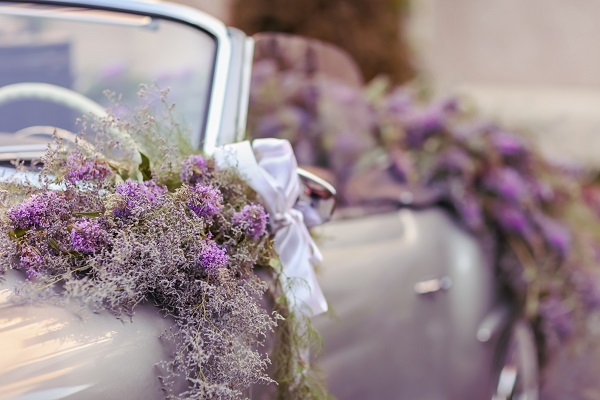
[411,0,600,167]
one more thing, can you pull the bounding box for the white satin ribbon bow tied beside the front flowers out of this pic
[213,139,327,317]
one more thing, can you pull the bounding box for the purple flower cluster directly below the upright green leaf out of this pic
[114,179,167,218]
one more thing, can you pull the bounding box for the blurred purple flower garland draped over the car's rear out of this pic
[249,47,600,362]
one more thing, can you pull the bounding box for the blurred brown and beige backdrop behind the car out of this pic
[180,0,600,167]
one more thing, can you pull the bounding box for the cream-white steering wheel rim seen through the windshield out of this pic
[0,82,142,165]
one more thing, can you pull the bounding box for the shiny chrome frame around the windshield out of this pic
[0,0,232,154]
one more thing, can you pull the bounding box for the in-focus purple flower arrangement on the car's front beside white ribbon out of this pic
[0,92,328,399]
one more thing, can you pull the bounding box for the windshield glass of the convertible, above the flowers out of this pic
[0,3,216,158]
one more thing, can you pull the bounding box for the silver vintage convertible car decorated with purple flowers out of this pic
[0,0,537,400]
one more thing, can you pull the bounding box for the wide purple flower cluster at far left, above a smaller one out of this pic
[8,191,69,229]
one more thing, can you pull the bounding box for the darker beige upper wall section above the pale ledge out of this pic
[414,0,600,87]
